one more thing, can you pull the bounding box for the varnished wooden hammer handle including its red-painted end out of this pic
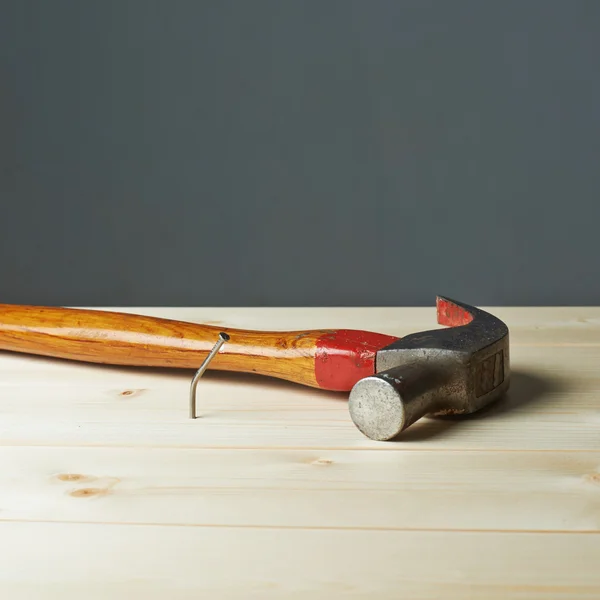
[0,304,397,391]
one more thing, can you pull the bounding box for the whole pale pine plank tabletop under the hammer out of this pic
[0,308,600,600]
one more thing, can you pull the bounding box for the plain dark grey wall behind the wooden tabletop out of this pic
[0,0,600,306]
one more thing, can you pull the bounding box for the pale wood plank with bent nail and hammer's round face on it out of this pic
[0,348,600,451]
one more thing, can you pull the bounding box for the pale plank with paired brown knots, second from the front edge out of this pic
[0,447,600,532]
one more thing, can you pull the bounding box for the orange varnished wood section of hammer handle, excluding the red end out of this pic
[0,305,326,386]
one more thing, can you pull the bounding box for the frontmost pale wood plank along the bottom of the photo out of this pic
[0,523,600,600]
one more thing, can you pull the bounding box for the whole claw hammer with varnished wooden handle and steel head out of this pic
[0,296,510,441]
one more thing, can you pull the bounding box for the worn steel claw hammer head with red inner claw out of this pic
[349,297,510,440]
